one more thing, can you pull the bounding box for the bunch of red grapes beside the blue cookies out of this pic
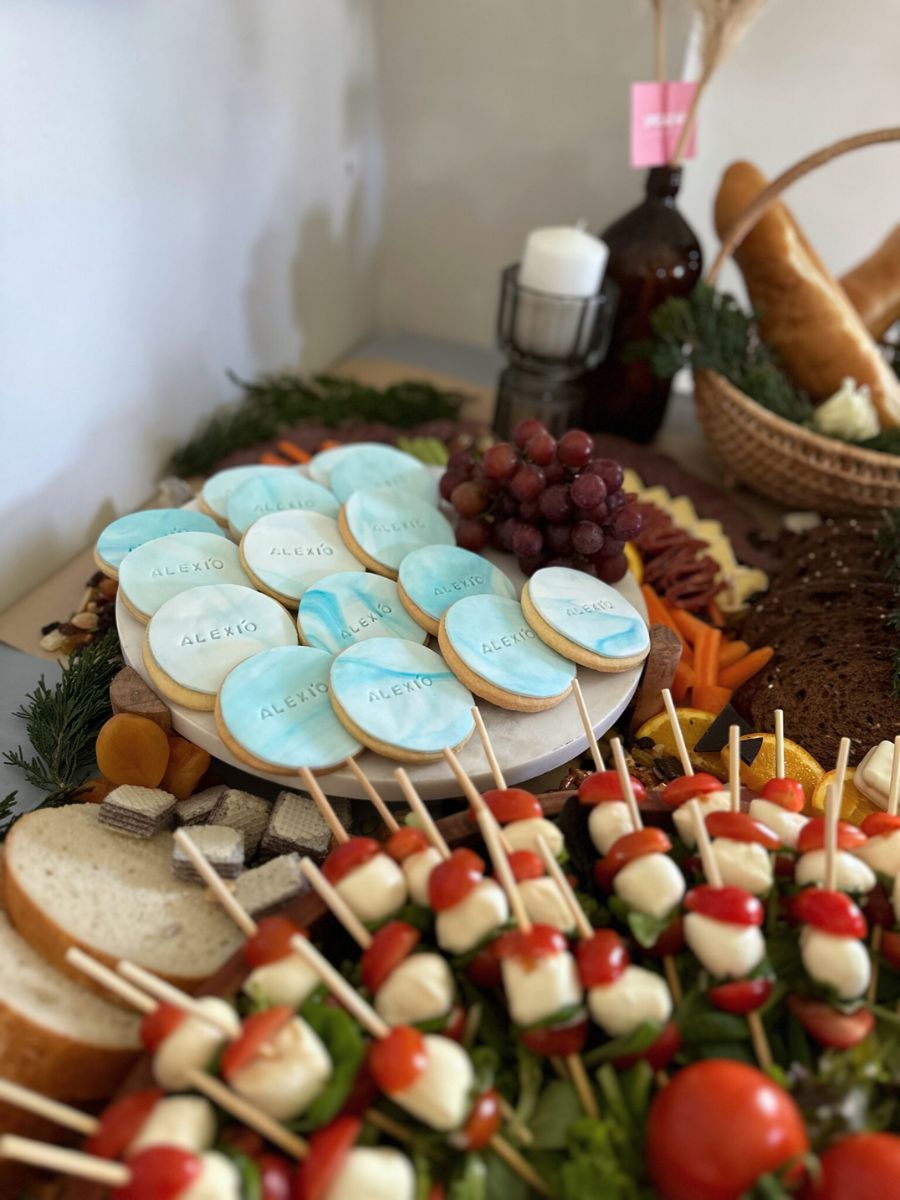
[440,418,641,583]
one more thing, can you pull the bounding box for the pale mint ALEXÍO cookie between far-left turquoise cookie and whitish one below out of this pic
[119,530,252,623]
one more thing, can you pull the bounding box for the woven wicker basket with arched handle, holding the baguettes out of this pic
[694,127,900,515]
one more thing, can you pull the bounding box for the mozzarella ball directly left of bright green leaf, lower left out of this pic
[229,1016,334,1121]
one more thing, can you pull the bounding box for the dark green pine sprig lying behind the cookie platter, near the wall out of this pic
[169,372,462,475]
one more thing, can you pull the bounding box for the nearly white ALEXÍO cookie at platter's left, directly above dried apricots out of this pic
[144,583,296,712]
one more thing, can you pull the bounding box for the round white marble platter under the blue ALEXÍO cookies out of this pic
[115,487,647,800]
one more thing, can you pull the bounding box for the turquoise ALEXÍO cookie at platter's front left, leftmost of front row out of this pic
[216,646,362,774]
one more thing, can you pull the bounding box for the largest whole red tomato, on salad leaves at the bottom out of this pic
[647,1058,809,1200]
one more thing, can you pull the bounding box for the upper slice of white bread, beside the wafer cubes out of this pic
[4,804,242,991]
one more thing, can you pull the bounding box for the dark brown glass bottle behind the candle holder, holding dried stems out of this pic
[584,167,703,442]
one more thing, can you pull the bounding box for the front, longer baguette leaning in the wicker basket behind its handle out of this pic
[715,162,900,427]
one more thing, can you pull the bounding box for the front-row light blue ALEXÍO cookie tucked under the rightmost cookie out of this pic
[438,595,575,713]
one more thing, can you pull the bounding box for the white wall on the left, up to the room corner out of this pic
[0,0,382,610]
